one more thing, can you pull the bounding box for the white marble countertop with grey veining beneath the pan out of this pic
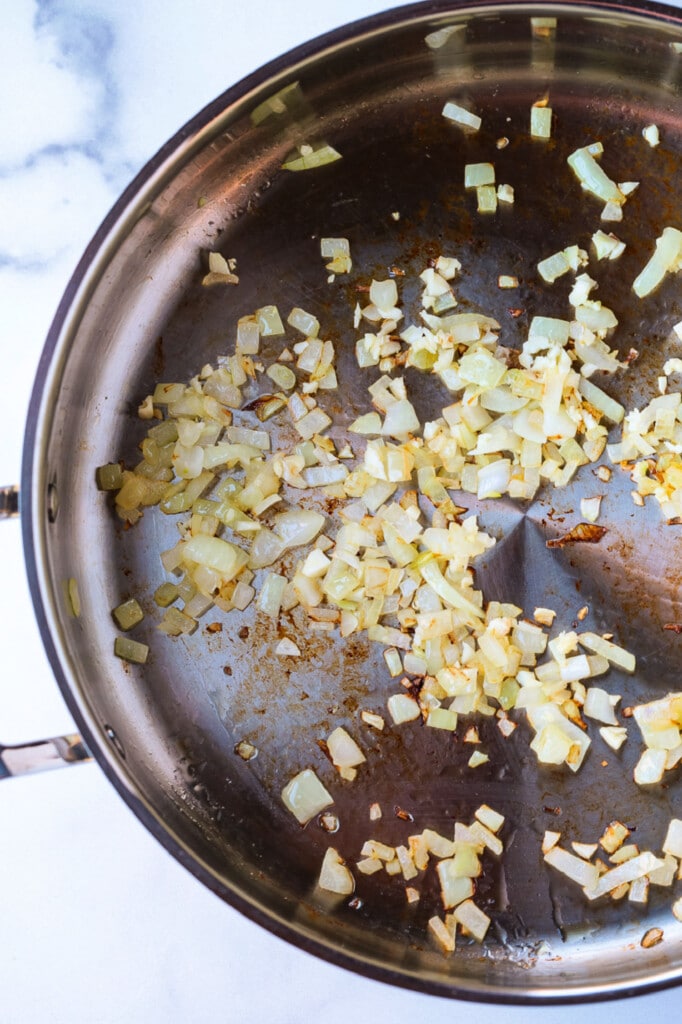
[0,0,679,1024]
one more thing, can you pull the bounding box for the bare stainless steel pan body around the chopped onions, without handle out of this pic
[15,4,682,1001]
